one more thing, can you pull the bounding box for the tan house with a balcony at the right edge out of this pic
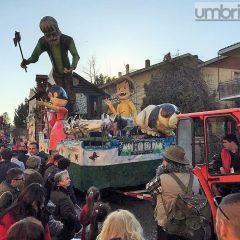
[202,43,240,108]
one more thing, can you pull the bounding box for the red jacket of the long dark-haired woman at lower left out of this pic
[0,213,51,240]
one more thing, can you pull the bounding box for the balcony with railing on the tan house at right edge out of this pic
[218,78,240,101]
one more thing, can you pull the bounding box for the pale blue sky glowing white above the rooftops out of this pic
[0,0,240,124]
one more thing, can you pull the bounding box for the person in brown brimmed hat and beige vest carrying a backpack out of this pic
[155,145,199,240]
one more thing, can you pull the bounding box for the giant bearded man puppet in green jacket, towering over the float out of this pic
[21,16,80,114]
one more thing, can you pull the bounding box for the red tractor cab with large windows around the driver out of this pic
[176,108,240,223]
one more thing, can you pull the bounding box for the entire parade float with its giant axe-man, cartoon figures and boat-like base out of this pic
[17,16,178,191]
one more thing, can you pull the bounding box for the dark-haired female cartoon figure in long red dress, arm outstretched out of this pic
[37,85,68,150]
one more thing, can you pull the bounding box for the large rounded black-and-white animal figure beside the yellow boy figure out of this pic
[136,103,180,136]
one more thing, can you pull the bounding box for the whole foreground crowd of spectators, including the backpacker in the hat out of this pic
[0,139,240,240]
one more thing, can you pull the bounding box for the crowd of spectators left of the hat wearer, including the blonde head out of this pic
[0,142,144,240]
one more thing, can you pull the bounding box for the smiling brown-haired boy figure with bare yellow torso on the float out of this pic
[105,76,137,122]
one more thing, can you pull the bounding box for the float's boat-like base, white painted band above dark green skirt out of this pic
[40,132,175,190]
